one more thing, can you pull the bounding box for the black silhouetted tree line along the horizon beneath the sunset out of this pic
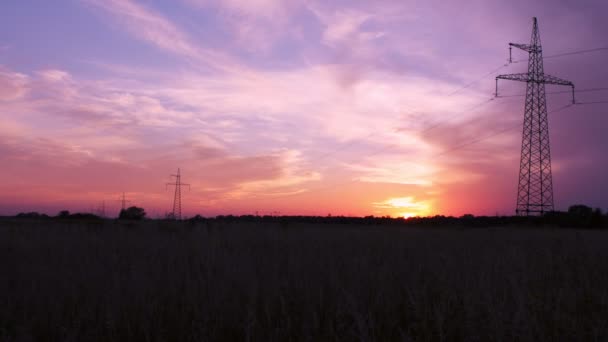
[8,204,608,229]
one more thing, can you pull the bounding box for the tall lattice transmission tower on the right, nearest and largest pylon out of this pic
[496,17,575,216]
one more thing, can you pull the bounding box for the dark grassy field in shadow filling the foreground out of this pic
[0,219,608,341]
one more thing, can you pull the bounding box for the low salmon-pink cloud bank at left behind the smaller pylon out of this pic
[0,130,298,212]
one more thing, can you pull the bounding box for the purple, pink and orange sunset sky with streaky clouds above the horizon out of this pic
[0,0,608,217]
